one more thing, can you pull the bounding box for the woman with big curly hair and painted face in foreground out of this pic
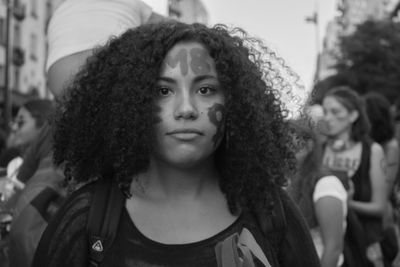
[33,22,319,267]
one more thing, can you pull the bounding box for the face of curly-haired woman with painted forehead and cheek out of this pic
[154,42,225,167]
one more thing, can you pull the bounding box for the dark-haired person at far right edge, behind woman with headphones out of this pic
[364,92,400,267]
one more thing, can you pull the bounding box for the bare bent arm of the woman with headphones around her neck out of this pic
[349,143,388,216]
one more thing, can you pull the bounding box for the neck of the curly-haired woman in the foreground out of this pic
[139,158,220,199]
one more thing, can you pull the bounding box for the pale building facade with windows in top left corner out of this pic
[0,0,61,103]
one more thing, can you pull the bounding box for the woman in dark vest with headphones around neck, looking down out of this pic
[322,87,387,260]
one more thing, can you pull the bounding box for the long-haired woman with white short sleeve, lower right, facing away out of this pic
[288,119,347,267]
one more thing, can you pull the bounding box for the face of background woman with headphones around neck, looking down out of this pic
[322,96,357,137]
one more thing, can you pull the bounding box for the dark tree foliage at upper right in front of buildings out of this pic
[336,20,400,103]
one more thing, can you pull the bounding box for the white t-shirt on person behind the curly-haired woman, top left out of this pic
[46,0,152,71]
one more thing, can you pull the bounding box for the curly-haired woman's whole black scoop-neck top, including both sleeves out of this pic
[32,185,319,267]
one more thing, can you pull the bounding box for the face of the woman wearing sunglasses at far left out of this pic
[12,107,40,146]
